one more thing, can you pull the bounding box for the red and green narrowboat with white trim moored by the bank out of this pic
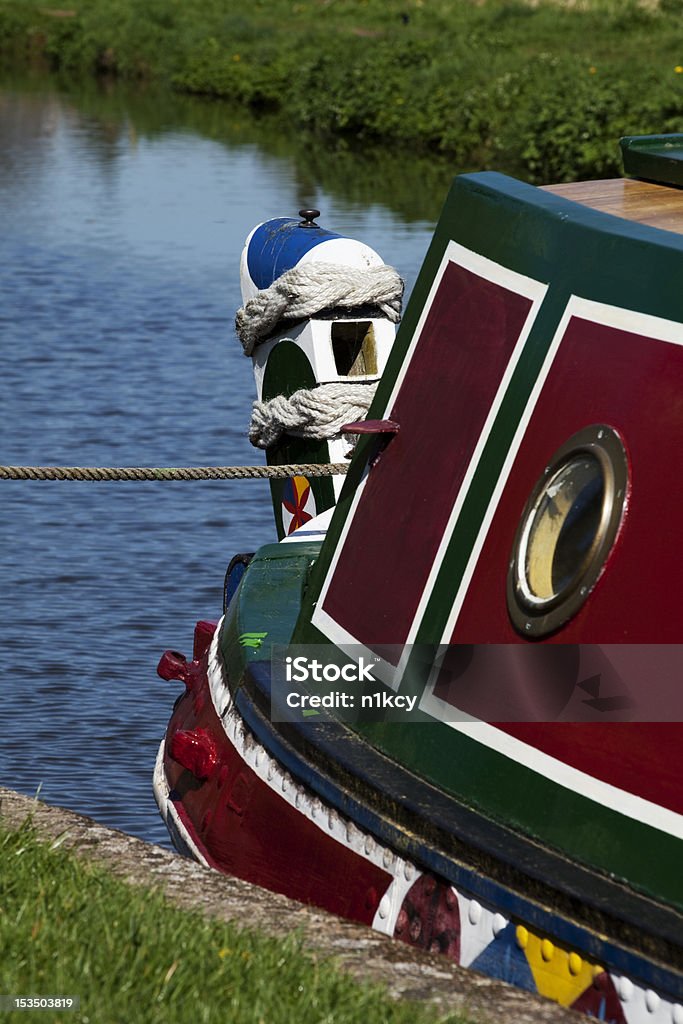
[155,136,683,1024]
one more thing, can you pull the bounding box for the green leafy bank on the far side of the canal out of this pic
[0,0,683,181]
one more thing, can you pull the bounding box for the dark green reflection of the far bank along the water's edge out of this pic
[0,69,458,223]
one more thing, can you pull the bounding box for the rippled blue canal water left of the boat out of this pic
[0,78,444,843]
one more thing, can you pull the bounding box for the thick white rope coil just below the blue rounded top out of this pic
[234,263,403,355]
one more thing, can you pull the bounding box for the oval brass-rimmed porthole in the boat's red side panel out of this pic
[508,426,628,637]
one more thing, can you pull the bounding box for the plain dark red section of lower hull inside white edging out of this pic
[164,655,391,925]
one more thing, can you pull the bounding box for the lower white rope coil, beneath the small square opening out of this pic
[249,381,378,449]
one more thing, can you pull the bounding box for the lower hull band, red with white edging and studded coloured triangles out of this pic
[158,624,678,1024]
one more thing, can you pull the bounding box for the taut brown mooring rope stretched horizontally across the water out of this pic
[0,462,348,480]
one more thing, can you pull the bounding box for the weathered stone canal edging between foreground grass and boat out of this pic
[0,786,578,1024]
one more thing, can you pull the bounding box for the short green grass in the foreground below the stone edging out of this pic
[0,824,471,1024]
